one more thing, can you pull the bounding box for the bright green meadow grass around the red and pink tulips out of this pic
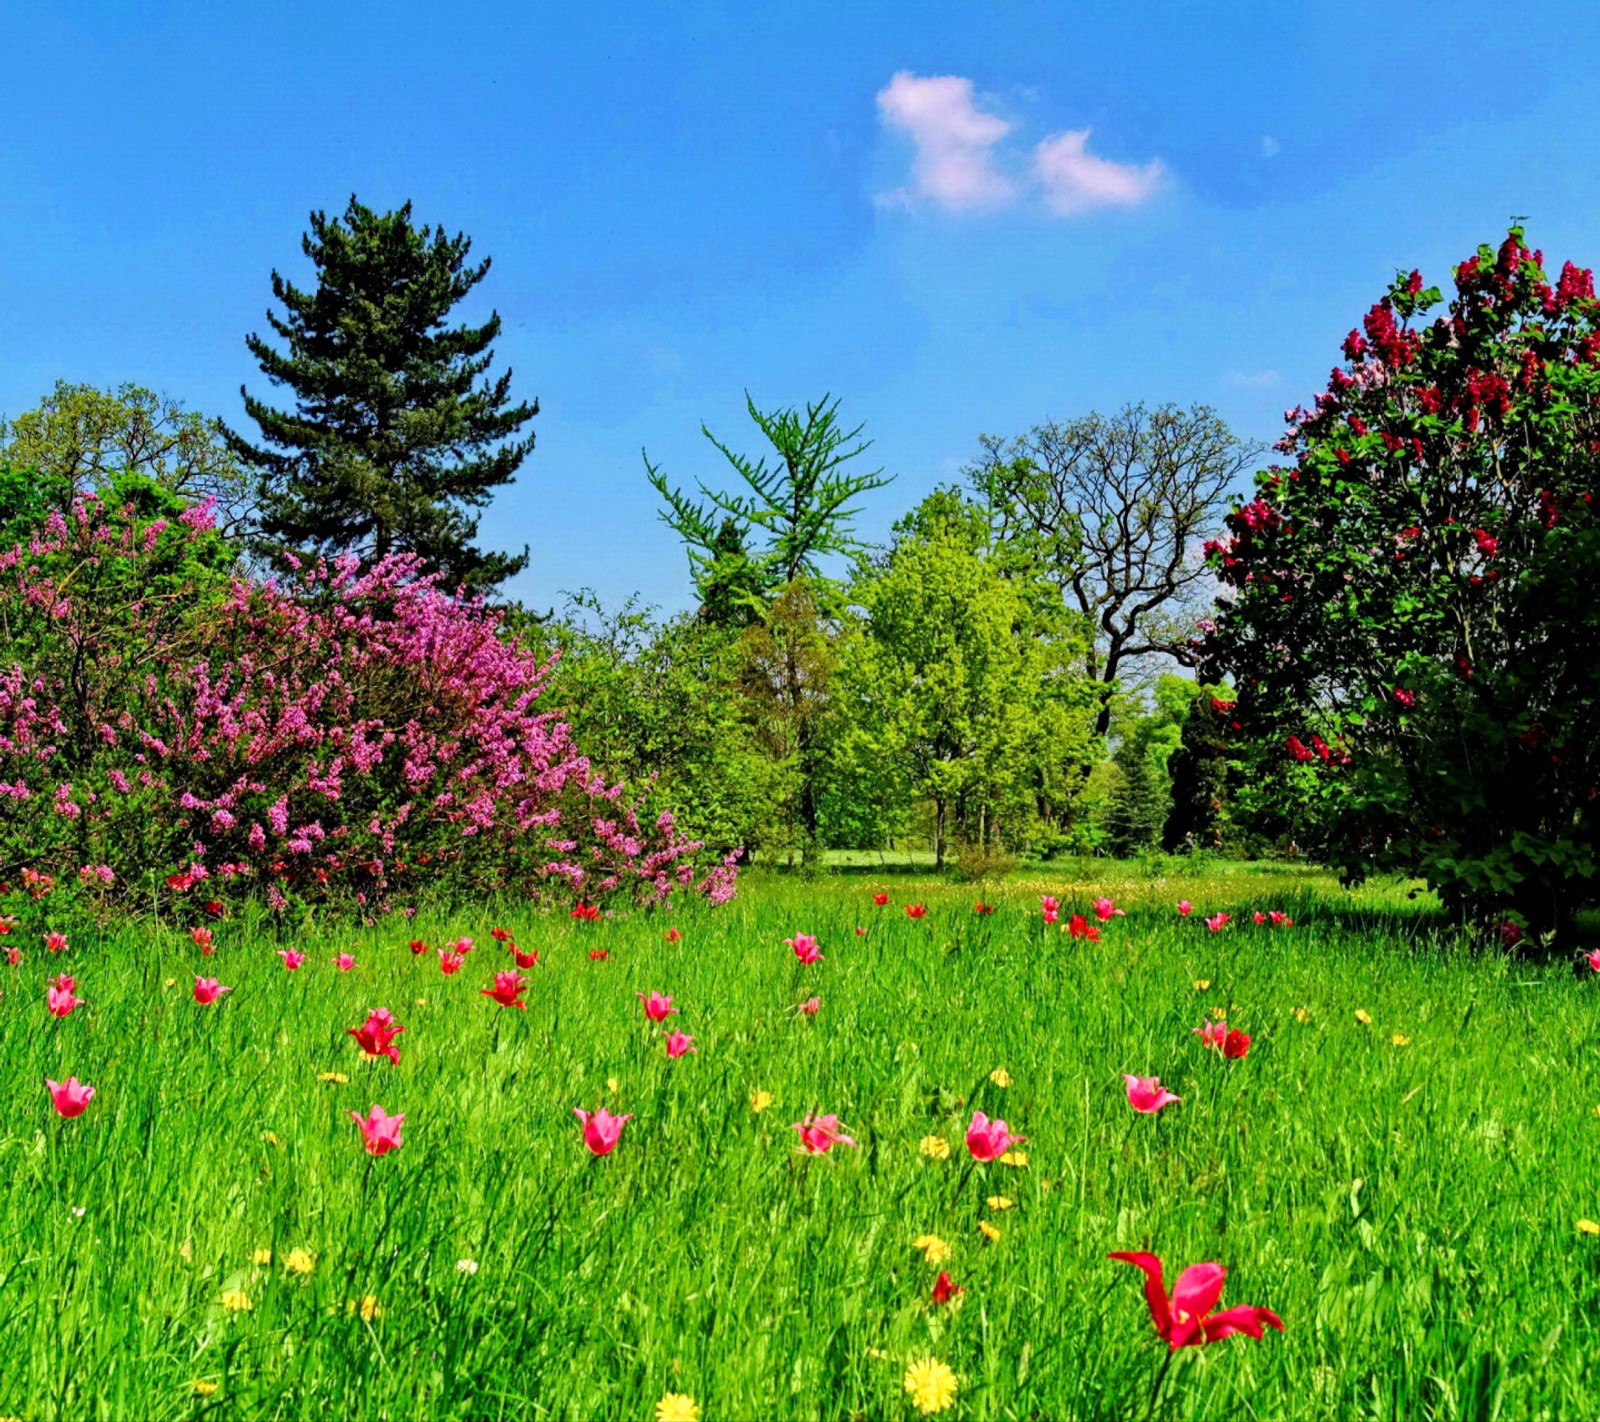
[9,865,1600,1422]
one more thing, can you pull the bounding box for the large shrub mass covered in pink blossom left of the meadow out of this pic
[0,499,733,909]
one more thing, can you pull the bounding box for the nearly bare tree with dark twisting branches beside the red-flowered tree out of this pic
[966,405,1262,736]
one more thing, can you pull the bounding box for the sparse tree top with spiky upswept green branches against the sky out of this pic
[645,395,890,621]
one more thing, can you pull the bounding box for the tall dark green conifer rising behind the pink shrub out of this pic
[227,197,539,590]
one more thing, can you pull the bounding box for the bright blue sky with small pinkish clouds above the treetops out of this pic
[0,0,1600,608]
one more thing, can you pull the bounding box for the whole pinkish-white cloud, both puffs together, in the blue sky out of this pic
[878,70,1165,218]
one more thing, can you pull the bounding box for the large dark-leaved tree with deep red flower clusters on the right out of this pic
[1202,229,1600,939]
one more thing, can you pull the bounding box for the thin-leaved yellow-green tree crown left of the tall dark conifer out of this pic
[0,381,253,531]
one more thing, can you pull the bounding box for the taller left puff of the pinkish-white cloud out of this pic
[878,69,1016,213]
